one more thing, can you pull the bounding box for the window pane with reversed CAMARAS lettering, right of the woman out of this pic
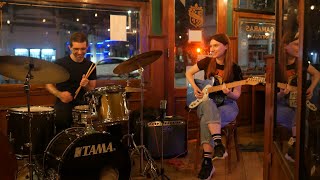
[238,18,275,75]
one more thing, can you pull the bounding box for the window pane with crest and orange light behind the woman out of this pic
[174,0,217,87]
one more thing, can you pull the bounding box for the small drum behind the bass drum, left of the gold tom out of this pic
[72,105,90,125]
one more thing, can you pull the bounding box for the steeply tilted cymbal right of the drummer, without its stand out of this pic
[113,51,162,74]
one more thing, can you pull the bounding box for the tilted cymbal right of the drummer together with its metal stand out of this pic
[113,51,162,178]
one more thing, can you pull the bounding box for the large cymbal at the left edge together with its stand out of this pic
[0,56,70,180]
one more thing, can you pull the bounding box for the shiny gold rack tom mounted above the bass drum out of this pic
[93,85,129,123]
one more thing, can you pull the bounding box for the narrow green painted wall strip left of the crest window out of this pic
[151,0,162,35]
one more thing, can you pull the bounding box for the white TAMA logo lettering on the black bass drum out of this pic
[74,142,115,158]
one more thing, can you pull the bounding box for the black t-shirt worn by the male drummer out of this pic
[55,56,97,105]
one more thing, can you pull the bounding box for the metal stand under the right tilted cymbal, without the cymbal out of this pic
[123,67,158,178]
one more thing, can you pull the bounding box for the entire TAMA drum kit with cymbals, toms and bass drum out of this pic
[0,51,162,180]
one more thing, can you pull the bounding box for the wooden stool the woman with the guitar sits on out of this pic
[186,108,240,173]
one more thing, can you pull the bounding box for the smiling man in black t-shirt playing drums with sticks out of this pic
[46,32,97,133]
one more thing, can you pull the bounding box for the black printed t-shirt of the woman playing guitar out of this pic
[197,57,243,81]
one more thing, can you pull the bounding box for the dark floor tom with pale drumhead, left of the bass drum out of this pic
[7,106,55,157]
